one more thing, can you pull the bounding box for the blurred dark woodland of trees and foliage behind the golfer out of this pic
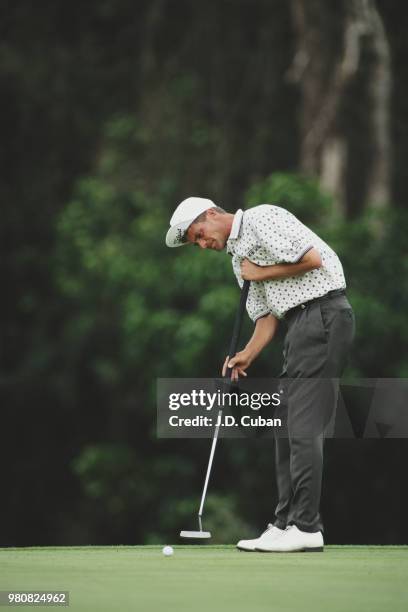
[0,0,408,546]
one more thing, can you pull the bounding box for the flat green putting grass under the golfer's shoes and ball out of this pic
[0,544,408,612]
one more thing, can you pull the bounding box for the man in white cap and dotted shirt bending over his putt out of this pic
[166,197,354,552]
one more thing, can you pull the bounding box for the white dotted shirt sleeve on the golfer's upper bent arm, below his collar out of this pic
[251,204,314,263]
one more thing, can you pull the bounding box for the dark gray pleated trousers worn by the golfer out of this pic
[274,292,354,532]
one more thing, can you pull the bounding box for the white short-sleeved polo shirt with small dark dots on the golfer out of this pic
[226,204,346,322]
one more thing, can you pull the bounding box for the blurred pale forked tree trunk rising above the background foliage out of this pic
[288,0,391,216]
